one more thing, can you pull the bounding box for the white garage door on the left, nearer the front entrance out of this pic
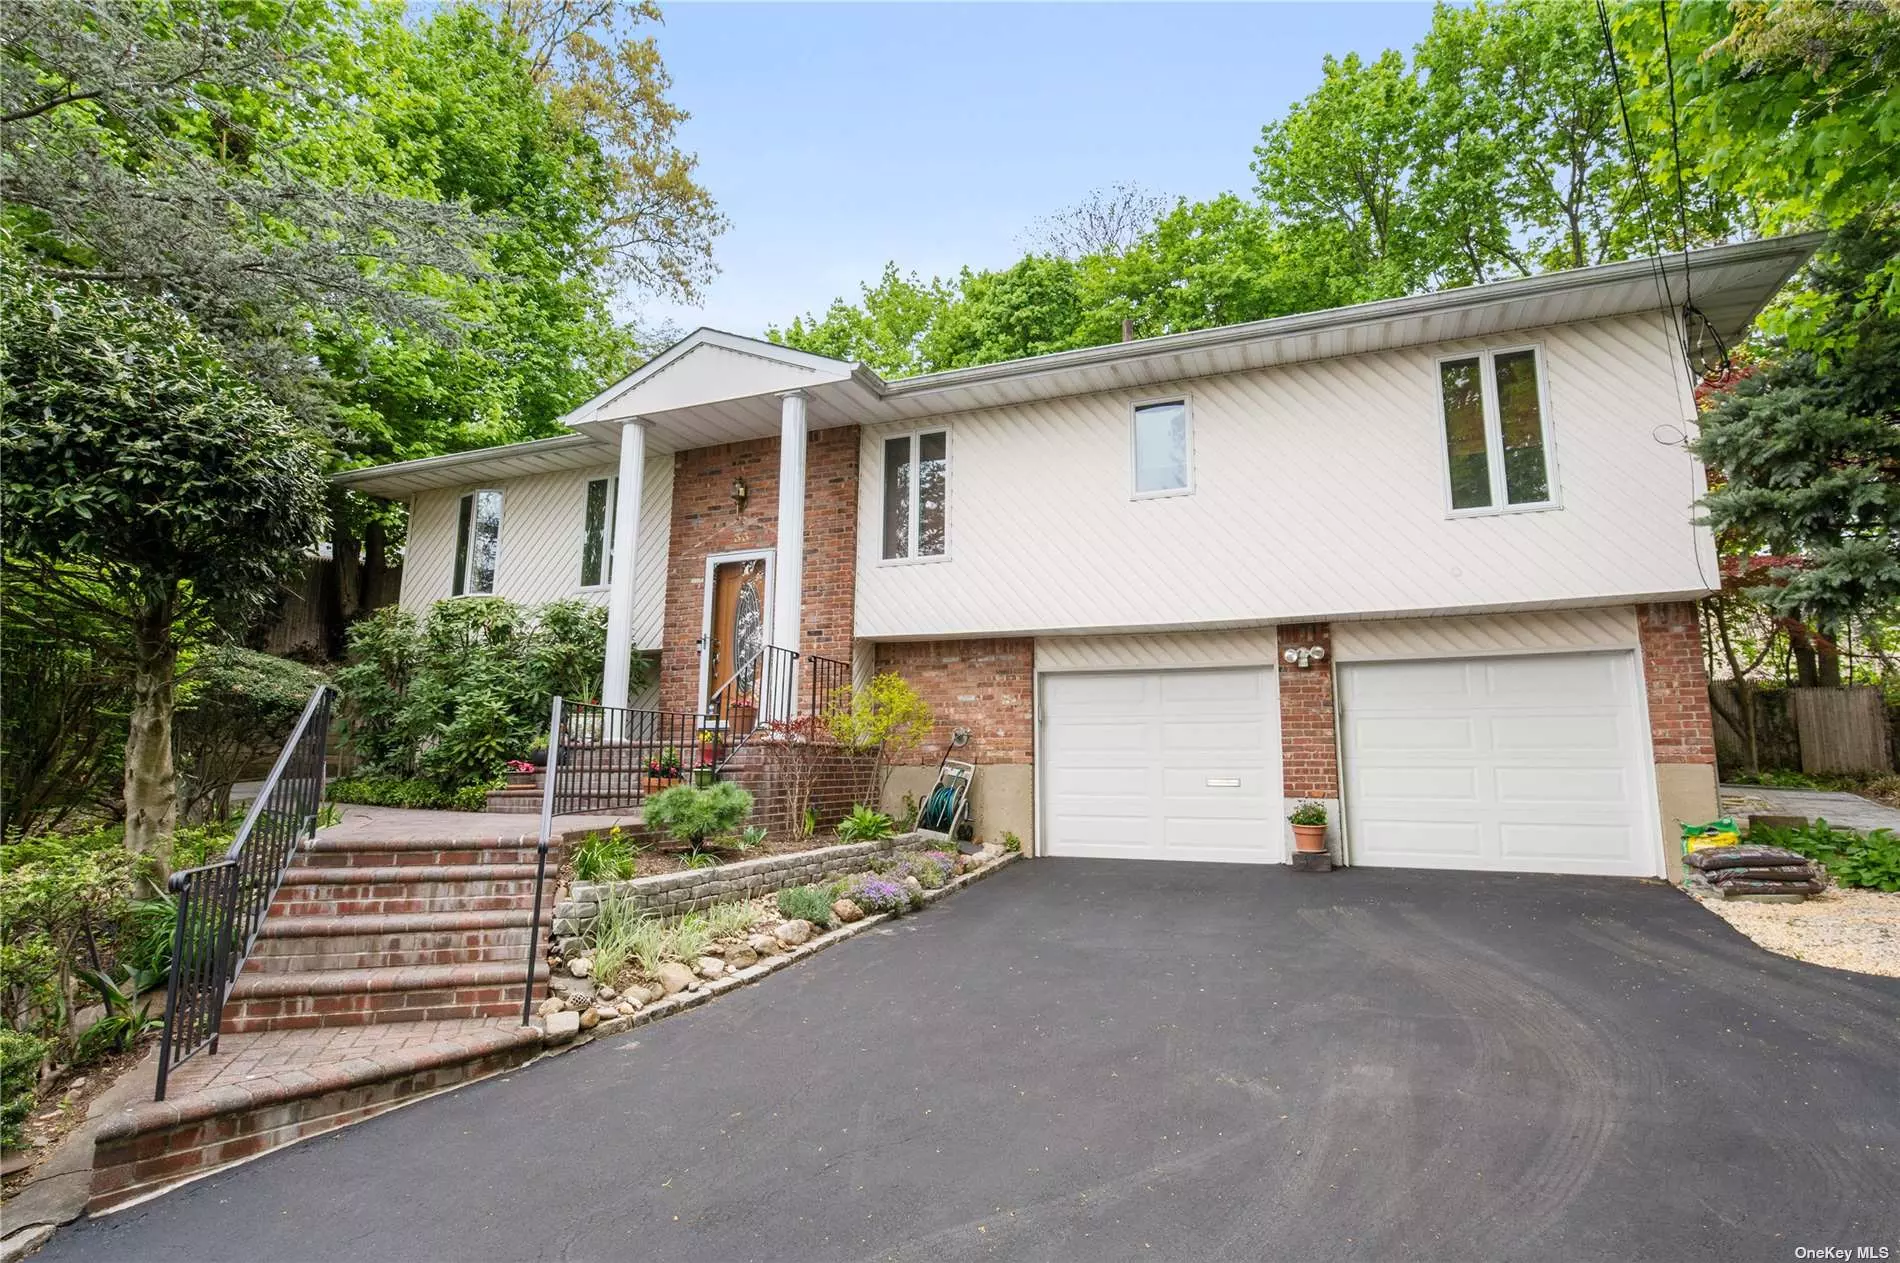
[1037,669,1284,862]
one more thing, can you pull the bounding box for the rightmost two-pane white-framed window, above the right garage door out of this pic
[1438,346,1556,513]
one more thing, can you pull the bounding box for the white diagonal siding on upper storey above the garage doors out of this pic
[855,317,1716,640]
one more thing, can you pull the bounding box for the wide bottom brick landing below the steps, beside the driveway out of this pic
[86,1022,542,1214]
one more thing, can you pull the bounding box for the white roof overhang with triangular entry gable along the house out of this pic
[333,234,1824,498]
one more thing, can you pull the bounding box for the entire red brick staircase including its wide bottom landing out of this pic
[89,817,559,1214]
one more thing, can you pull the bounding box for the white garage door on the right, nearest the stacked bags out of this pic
[1340,653,1661,877]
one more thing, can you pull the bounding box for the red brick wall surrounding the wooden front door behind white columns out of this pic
[659,425,857,710]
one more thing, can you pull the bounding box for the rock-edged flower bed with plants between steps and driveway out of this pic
[538,836,1017,1041]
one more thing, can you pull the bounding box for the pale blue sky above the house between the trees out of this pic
[635,2,1431,334]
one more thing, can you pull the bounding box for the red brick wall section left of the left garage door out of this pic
[878,638,1036,763]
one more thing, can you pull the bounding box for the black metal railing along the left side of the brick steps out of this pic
[154,684,336,1100]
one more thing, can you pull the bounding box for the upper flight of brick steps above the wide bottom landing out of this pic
[220,838,553,1035]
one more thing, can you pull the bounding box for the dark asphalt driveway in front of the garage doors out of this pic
[42,860,1900,1263]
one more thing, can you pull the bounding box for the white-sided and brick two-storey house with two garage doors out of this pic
[338,237,1815,877]
